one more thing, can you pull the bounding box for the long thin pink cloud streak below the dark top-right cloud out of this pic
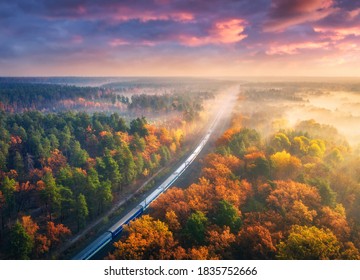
[266,42,329,55]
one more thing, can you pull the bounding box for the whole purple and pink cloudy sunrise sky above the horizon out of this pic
[0,0,360,77]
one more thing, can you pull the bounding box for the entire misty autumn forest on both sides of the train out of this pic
[0,78,360,260]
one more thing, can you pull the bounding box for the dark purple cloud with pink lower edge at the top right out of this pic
[264,0,336,32]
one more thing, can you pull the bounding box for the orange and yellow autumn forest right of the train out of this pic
[107,84,360,260]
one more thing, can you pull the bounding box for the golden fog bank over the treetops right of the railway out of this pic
[240,81,360,146]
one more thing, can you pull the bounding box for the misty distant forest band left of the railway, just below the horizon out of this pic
[0,78,219,121]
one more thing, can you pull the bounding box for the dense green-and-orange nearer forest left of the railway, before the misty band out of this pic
[0,112,190,258]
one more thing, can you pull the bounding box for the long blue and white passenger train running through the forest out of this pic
[73,111,222,260]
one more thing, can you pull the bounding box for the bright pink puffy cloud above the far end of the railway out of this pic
[179,19,247,47]
